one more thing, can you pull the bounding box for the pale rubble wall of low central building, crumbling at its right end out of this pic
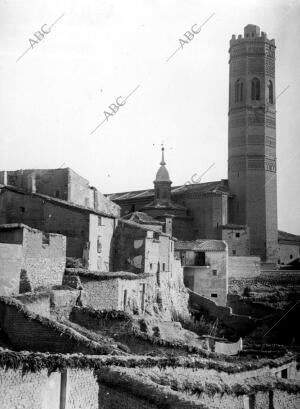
[80,260,189,320]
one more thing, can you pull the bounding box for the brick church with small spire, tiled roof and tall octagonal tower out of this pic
[109,24,292,263]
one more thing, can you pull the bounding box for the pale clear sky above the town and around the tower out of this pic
[0,0,300,234]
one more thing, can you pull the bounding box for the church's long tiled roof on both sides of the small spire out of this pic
[106,180,228,201]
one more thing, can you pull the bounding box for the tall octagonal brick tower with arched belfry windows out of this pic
[228,24,278,262]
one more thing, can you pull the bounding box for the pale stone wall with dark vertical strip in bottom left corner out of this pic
[0,368,99,409]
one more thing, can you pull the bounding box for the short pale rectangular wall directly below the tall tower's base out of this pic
[228,256,260,279]
